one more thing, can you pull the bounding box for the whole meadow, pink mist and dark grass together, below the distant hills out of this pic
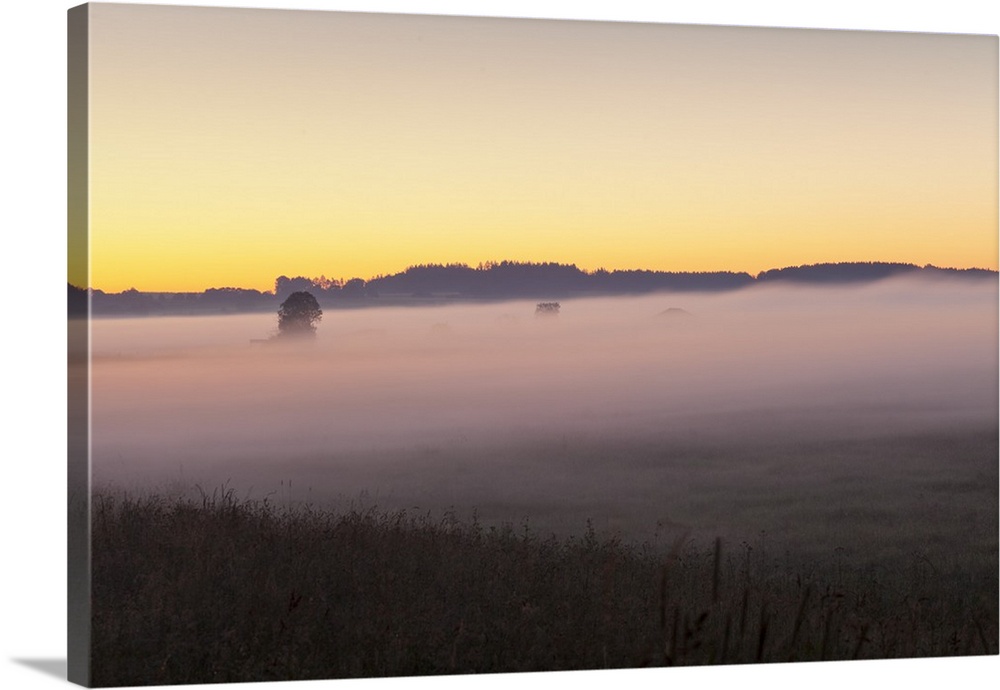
[82,278,998,684]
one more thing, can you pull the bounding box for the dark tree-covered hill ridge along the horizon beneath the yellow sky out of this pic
[69,261,997,316]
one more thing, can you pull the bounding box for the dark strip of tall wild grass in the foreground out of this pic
[92,489,997,686]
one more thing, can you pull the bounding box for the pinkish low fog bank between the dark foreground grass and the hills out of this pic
[92,279,998,552]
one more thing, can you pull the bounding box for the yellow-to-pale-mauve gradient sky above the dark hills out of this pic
[82,4,998,291]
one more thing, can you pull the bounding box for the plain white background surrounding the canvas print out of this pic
[0,0,1000,690]
